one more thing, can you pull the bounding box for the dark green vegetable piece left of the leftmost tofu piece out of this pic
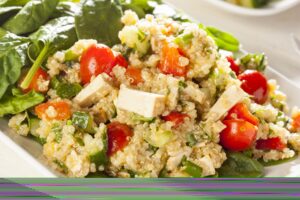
[56,83,82,99]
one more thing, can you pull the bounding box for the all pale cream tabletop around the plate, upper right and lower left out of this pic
[0,0,300,177]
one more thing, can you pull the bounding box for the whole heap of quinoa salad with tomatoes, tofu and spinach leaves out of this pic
[0,0,300,178]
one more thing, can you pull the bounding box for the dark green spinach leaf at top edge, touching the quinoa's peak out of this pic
[75,0,123,46]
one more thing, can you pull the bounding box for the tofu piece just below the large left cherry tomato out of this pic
[74,74,113,107]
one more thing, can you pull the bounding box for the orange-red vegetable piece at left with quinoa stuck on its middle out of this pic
[35,101,71,120]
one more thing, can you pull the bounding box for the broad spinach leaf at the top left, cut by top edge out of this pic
[3,0,58,35]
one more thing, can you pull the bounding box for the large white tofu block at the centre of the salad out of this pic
[116,85,166,117]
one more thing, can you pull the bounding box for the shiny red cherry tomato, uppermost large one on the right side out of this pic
[238,70,268,104]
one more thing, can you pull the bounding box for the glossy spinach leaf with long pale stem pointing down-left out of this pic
[21,17,77,89]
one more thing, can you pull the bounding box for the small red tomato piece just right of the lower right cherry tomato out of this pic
[256,137,286,151]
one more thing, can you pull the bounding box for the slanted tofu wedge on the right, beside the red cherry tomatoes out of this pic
[207,85,247,121]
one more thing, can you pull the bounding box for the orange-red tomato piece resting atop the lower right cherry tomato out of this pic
[224,103,259,126]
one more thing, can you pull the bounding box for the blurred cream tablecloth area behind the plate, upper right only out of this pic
[167,0,300,84]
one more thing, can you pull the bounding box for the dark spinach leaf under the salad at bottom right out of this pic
[218,152,264,178]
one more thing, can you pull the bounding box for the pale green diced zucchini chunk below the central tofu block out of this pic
[145,130,173,147]
